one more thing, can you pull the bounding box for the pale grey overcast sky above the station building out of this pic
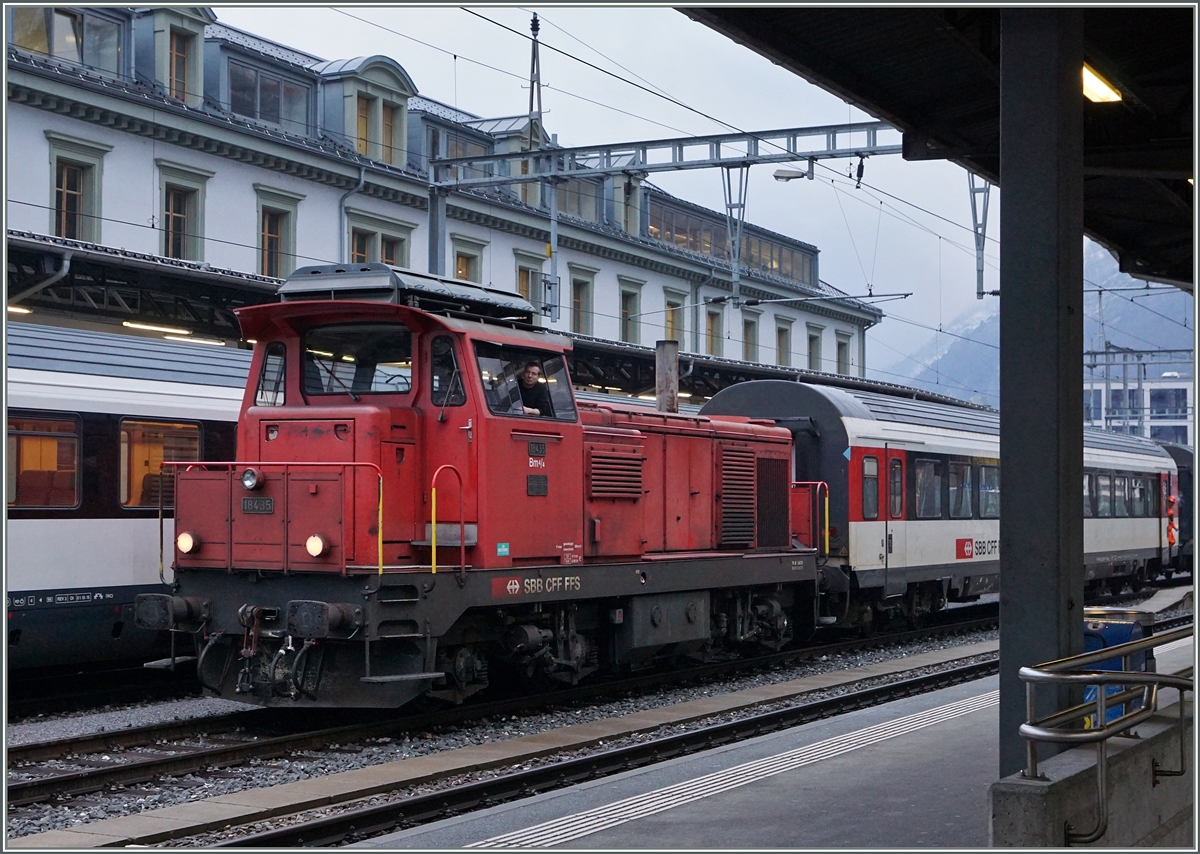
[215,6,1000,380]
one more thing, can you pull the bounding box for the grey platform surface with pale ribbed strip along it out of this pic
[356,641,1193,850]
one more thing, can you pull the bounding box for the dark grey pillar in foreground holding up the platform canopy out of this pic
[1000,8,1084,777]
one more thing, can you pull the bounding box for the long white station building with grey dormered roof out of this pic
[6,7,883,395]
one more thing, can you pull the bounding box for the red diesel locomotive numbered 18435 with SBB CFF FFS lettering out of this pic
[137,265,820,706]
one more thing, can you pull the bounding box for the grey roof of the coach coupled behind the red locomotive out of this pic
[701,380,1170,457]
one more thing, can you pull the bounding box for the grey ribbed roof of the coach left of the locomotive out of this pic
[7,320,251,389]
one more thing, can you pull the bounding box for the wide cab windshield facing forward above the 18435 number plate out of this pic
[304,323,413,399]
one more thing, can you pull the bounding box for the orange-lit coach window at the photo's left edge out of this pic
[6,415,79,507]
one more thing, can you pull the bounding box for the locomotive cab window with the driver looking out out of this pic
[475,342,575,421]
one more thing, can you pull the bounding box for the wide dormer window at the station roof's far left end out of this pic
[8,6,124,74]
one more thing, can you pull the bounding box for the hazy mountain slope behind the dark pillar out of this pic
[868,240,1195,407]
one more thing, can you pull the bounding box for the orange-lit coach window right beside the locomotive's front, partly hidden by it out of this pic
[120,419,200,507]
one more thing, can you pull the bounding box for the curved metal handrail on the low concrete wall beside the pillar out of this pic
[1018,625,1195,844]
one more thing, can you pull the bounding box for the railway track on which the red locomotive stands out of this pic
[7,606,997,806]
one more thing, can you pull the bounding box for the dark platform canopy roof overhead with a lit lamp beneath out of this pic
[682,5,1195,291]
